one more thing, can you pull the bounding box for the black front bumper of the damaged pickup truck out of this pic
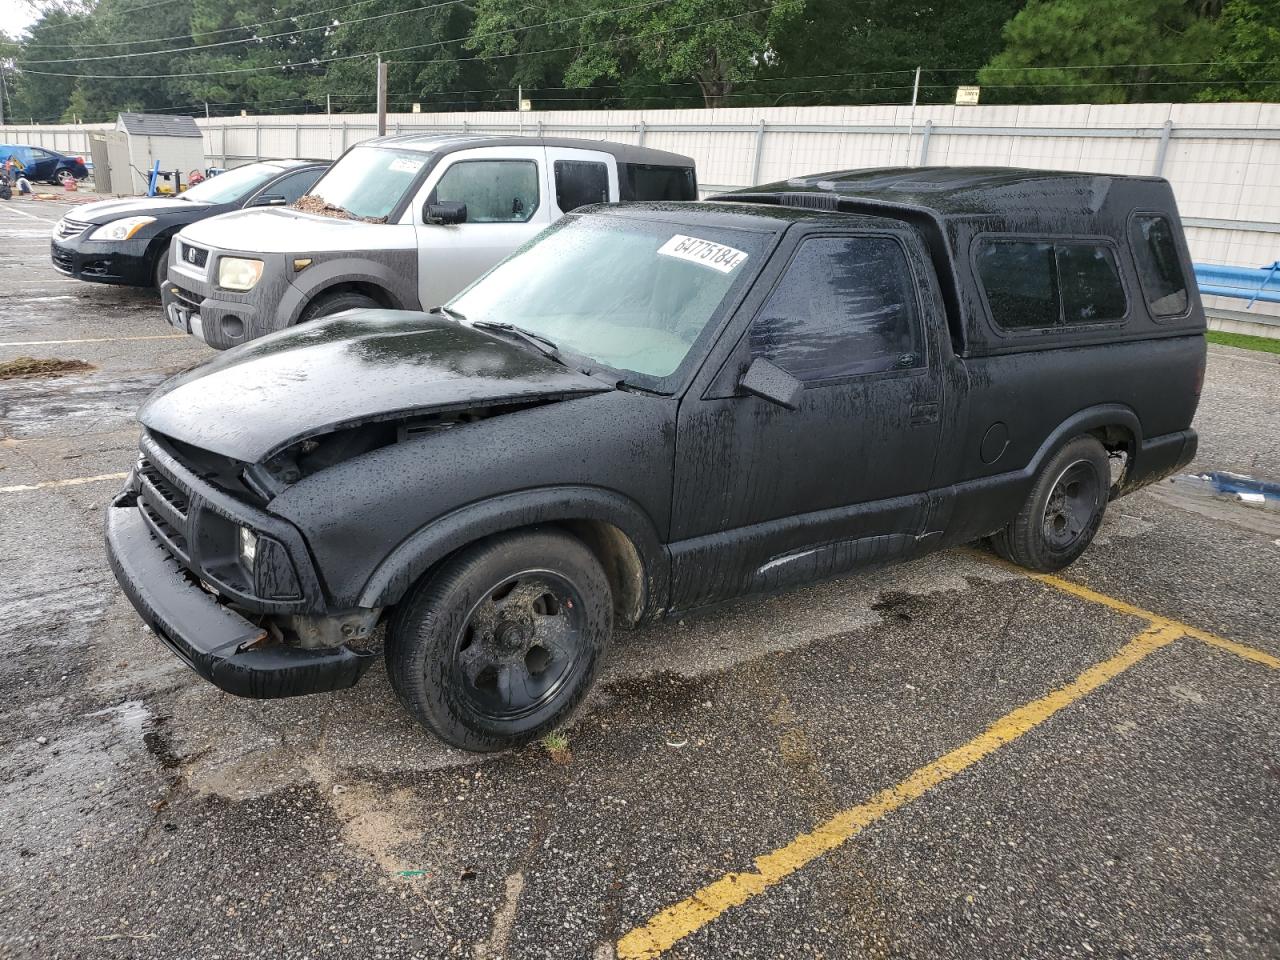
[106,497,376,699]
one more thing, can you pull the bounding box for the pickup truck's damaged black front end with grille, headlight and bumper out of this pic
[106,434,381,699]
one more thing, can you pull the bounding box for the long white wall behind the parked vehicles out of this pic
[0,104,1280,335]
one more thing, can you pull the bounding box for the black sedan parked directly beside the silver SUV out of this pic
[52,160,329,288]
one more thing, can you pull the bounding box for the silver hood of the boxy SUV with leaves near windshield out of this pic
[182,207,417,256]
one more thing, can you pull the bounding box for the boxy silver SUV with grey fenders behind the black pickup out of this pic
[163,134,698,349]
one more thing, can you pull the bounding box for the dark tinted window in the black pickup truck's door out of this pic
[750,237,924,381]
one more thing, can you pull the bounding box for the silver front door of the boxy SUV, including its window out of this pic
[410,146,547,308]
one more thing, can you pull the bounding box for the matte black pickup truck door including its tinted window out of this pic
[671,230,945,607]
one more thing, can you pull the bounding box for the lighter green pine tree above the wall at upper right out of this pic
[979,0,1221,104]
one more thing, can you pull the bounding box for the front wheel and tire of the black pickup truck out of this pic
[385,530,613,751]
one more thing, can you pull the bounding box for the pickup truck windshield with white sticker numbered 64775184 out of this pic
[449,214,767,390]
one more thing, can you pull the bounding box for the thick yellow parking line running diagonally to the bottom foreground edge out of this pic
[617,624,1184,960]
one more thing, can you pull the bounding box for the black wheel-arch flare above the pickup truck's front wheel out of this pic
[358,485,669,612]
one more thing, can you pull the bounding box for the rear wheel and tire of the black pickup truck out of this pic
[991,436,1111,573]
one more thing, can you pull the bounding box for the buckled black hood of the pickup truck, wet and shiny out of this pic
[138,310,608,463]
